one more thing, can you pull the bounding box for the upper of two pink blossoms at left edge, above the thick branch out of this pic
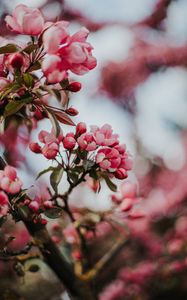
[0,166,22,194]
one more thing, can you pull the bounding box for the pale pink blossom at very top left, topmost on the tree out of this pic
[5,4,44,35]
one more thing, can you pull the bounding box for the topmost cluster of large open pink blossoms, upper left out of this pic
[5,4,96,83]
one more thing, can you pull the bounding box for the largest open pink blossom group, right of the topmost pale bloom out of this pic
[42,25,97,81]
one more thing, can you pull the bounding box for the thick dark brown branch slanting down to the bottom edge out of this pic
[0,157,96,300]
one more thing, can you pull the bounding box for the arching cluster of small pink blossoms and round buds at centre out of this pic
[30,122,132,179]
